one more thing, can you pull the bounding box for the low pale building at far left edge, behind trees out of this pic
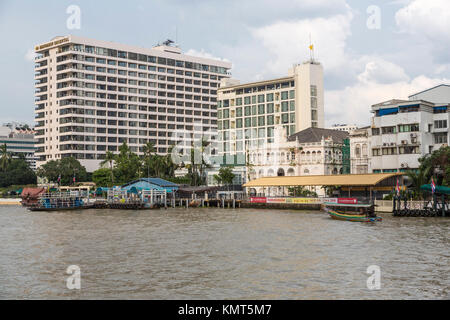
[0,123,36,170]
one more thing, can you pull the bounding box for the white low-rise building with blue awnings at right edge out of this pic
[369,85,450,173]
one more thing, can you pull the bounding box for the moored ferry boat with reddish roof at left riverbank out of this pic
[27,192,92,211]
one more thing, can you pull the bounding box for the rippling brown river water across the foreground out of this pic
[0,206,450,299]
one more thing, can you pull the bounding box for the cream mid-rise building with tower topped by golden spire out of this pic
[217,60,324,166]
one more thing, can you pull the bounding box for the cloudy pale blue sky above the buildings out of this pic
[0,0,450,126]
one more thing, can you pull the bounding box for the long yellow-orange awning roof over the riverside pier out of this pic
[244,173,402,188]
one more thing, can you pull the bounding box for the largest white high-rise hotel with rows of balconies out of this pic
[35,35,231,171]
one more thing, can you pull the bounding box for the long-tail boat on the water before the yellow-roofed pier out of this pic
[324,202,382,222]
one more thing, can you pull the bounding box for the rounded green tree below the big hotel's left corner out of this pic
[37,157,88,185]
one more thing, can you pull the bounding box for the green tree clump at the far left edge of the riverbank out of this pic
[0,158,37,187]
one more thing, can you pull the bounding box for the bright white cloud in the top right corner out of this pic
[395,0,450,41]
